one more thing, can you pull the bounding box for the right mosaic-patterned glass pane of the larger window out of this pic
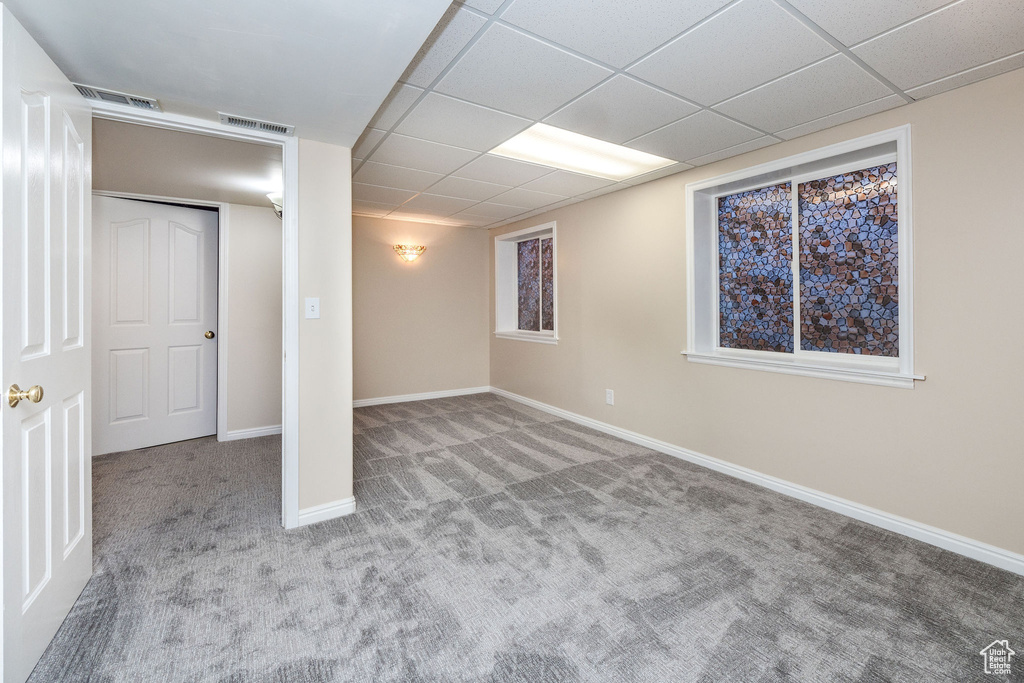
[799,163,899,357]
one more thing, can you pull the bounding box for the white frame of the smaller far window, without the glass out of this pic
[495,221,558,344]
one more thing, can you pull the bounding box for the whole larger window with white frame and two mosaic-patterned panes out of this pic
[685,127,924,388]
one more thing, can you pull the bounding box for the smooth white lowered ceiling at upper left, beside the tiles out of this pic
[5,0,451,146]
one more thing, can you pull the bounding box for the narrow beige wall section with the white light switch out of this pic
[298,139,352,510]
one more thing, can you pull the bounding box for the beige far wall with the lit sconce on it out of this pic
[352,216,490,399]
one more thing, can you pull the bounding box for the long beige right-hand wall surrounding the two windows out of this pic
[490,71,1024,553]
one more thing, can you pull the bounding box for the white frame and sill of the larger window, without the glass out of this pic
[683,126,925,389]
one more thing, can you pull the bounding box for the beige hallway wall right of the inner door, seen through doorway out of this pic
[226,204,282,431]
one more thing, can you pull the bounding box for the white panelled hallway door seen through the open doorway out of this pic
[92,197,218,455]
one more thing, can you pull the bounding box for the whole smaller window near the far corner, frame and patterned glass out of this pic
[495,222,558,344]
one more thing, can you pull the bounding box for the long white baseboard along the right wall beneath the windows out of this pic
[490,387,1024,575]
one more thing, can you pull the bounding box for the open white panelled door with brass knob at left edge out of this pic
[0,7,92,683]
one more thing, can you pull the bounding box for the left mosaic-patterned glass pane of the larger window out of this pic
[718,182,794,353]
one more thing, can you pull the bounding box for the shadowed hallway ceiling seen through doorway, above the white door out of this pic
[92,119,284,209]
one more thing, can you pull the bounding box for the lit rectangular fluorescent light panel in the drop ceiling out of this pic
[490,123,676,180]
